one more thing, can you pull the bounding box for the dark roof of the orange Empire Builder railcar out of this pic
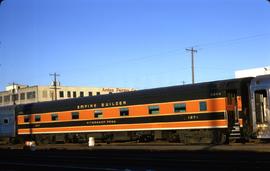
[17,77,252,114]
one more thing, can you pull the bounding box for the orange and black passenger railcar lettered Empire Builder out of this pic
[13,78,256,144]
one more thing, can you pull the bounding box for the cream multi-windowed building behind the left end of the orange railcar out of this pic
[0,84,135,106]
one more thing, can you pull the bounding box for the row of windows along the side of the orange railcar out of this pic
[24,101,207,122]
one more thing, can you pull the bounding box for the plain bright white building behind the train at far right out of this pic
[235,66,270,78]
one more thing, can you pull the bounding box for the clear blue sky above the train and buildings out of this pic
[0,0,270,90]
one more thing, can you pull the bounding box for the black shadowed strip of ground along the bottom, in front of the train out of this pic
[0,150,270,171]
